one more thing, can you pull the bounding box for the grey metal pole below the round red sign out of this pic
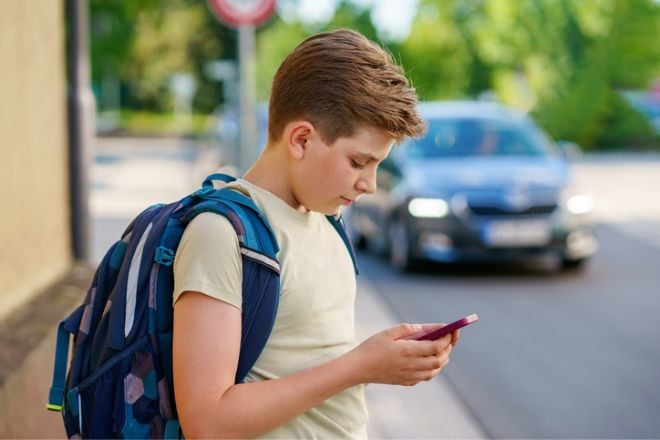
[238,24,258,173]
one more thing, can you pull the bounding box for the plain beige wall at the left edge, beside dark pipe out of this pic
[0,0,72,319]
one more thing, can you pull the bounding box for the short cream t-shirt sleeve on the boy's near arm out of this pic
[172,213,243,310]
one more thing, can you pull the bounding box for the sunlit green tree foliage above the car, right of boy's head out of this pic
[397,0,660,149]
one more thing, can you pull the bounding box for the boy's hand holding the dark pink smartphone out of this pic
[349,324,459,386]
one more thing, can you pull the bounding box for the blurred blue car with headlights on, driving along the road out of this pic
[346,101,598,270]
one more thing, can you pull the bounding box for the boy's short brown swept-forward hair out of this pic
[268,29,426,144]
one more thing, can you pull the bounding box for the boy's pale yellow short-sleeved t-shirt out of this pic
[174,179,367,438]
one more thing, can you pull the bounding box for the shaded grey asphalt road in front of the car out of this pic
[360,225,660,438]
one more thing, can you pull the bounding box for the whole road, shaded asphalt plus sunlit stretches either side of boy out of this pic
[91,139,660,438]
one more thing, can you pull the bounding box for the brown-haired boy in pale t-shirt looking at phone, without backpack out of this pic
[173,30,459,438]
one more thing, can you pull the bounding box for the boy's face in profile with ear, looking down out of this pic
[292,127,394,215]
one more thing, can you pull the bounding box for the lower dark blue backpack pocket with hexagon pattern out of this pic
[71,335,163,438]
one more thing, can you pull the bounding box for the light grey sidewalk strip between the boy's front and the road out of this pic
[356,275,486,439]
